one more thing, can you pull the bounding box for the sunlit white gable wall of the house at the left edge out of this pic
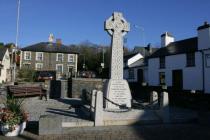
[0,49,10,83]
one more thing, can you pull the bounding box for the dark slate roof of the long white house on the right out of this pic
[149,37,198,58]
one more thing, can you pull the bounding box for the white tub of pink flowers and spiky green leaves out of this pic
[0,97,28,136]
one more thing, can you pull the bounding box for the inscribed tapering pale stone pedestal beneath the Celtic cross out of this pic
[105,79,131,109]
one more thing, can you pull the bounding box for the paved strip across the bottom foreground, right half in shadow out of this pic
[0,124,210,140]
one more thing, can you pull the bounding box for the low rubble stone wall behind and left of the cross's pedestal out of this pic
[71,78,107,98]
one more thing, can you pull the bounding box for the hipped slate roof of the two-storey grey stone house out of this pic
[21,42,78,54]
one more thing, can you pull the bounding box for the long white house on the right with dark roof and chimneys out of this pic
[148,22,210,93]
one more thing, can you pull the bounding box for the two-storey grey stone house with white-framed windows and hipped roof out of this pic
[20,41,78,78]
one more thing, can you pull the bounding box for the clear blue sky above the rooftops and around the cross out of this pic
[0,0,210,48]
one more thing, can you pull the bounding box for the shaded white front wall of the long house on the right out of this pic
[148,52,202,90]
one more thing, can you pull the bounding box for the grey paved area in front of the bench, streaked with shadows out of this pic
[24,97,81,121]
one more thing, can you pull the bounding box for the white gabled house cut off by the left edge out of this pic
[0,47,10,83]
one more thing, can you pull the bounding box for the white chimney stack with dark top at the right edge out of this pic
[197,22,210,50]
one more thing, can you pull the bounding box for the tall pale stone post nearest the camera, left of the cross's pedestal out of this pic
[94,91,103,126]
